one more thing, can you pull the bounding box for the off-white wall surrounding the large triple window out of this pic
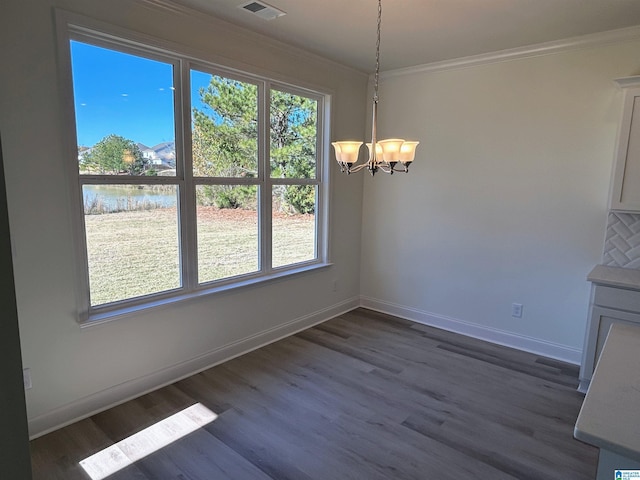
[0,0,367,435]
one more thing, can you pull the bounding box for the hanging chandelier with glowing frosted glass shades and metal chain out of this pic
[332,0,420,175]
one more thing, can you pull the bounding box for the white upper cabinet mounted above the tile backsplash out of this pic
[610,76,640,212]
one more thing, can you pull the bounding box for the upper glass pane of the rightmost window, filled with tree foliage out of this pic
[270,90,318,178]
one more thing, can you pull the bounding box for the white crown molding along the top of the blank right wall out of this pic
[380,26,640,78]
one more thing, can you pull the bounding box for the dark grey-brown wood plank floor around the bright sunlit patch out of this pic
[31,309,597,480]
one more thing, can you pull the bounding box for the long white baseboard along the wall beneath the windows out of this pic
[28,297,360,440]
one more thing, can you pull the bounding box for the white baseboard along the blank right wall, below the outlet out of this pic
[360,296,582,365]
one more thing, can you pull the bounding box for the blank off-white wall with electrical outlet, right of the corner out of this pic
[362,40,640,362]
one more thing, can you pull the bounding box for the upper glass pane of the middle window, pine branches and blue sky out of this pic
[191,70,258,177]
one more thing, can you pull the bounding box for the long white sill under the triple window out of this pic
[78,263,333,328]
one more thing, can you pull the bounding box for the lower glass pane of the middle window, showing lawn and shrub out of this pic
[196,185,260,283]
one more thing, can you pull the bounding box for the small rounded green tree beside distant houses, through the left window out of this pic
[80,134,148,175]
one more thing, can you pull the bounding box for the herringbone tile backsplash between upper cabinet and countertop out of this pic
[602,212,640,269]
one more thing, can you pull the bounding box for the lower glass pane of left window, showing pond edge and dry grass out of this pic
[82,185,181,306]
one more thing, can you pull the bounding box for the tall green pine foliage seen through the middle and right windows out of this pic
[193,76,317,213]
